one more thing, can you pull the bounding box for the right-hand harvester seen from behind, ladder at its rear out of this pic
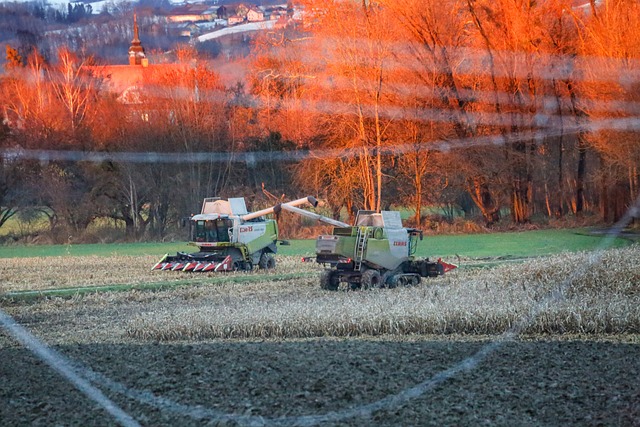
[282,205,457,291]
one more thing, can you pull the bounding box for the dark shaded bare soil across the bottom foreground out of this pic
[0,340,640,426]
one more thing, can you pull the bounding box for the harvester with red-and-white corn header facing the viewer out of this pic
[152,197,317,272]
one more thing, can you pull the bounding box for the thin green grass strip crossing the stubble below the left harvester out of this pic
[0,272,309,302]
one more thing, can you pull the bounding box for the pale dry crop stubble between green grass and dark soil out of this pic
[1,245,640,341]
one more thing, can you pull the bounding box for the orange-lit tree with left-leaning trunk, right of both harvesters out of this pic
[382,0,510,224]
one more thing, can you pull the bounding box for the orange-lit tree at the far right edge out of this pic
[575,0,640,221]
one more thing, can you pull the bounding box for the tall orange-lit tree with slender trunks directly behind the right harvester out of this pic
[303,0,393,211]
